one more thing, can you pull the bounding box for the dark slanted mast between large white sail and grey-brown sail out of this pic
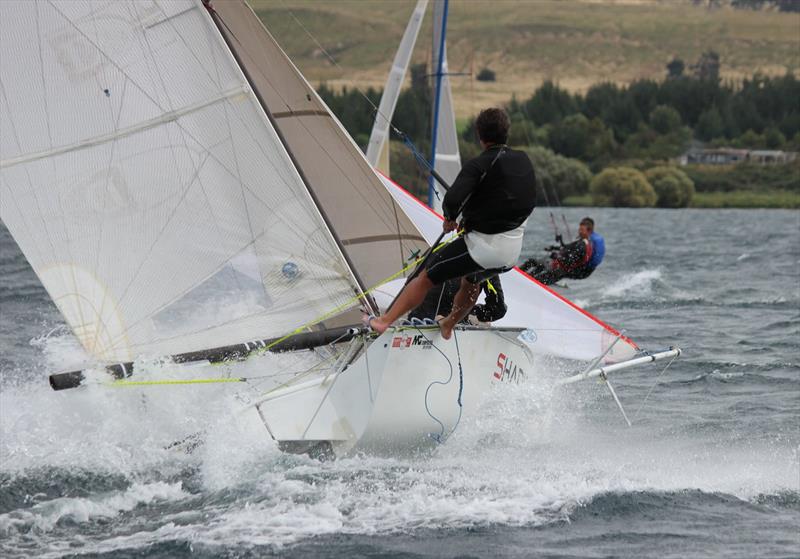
[201,0,379,314]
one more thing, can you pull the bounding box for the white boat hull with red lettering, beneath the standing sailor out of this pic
[257,327,534,454]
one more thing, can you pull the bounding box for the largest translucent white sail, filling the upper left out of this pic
[0,0,358,361]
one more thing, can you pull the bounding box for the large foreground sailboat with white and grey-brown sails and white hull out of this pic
[0,0,680,455]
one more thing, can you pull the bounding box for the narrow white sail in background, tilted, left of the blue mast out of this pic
[367,0,428,175]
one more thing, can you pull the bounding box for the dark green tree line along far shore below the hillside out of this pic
[319,55,800,207]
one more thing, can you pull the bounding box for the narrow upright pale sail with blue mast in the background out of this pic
[431,0,461,213]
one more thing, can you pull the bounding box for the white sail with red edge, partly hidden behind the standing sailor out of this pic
[383,177,638,362]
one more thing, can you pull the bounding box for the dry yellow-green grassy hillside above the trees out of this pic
[248,0,800,118]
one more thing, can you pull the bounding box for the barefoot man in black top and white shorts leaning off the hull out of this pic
[368,109,536,339]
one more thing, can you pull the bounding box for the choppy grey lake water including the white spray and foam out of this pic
[0,209,800,558]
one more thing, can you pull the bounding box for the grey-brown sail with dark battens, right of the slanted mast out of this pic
[213,0,428,288]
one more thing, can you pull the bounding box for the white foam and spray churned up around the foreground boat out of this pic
[0,336,797,555]
